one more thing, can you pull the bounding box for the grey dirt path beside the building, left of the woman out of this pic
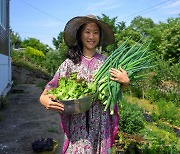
[0,84,63,154]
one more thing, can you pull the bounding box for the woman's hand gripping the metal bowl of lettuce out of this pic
[40,89,64,113]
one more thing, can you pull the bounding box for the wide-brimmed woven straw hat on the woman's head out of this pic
[64,15,115,47]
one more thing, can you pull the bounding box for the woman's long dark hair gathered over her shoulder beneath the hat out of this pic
[66,24,101,64]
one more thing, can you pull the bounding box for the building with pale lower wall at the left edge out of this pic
[0,0,12,97]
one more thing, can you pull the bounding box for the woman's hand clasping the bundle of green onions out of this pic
[109,67,130,86]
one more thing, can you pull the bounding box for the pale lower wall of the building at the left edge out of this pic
[0,54,12,96]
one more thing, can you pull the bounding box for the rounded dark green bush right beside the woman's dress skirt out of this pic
[119,101,145,134]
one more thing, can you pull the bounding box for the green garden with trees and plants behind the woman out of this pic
[11,14,180,154]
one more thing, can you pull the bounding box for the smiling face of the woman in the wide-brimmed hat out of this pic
[81,23,100,50]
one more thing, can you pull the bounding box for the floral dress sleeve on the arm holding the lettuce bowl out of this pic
[45,59,72,90]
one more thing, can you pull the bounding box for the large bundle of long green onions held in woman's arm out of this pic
[93,40,154,115]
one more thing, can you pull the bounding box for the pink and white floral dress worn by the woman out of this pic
[46,53,119,154]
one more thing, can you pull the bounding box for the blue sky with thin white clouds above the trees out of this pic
[10,0,180,48]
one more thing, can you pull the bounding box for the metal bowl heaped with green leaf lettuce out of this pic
[48,72,96,114]
